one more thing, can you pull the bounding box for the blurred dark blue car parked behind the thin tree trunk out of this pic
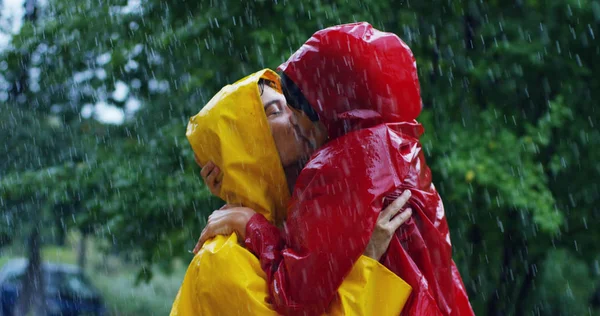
[0,259,105,316]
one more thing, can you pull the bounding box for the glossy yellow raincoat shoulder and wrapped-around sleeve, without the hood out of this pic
[171,234,410,316]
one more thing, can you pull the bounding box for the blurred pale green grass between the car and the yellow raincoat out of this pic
[0,233,186,315]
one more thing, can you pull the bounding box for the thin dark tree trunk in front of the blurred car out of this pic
[15,225,46,315]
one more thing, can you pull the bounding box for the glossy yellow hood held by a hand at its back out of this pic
[186,69,290,224]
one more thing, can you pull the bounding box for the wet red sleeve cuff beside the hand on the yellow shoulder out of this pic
[244,214,284,277]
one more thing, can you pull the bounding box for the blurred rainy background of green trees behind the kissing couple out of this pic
[0,0,600,315]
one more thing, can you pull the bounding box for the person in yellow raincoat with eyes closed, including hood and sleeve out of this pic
[171,69,410,315]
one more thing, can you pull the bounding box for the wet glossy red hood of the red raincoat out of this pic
[279,22,421,138]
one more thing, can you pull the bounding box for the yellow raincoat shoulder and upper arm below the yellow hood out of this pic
[171,234,277,316]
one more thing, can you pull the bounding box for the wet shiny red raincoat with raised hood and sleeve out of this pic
[246,23,473,315]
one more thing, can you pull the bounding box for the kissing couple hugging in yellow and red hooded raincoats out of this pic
[171,23,473,315]
